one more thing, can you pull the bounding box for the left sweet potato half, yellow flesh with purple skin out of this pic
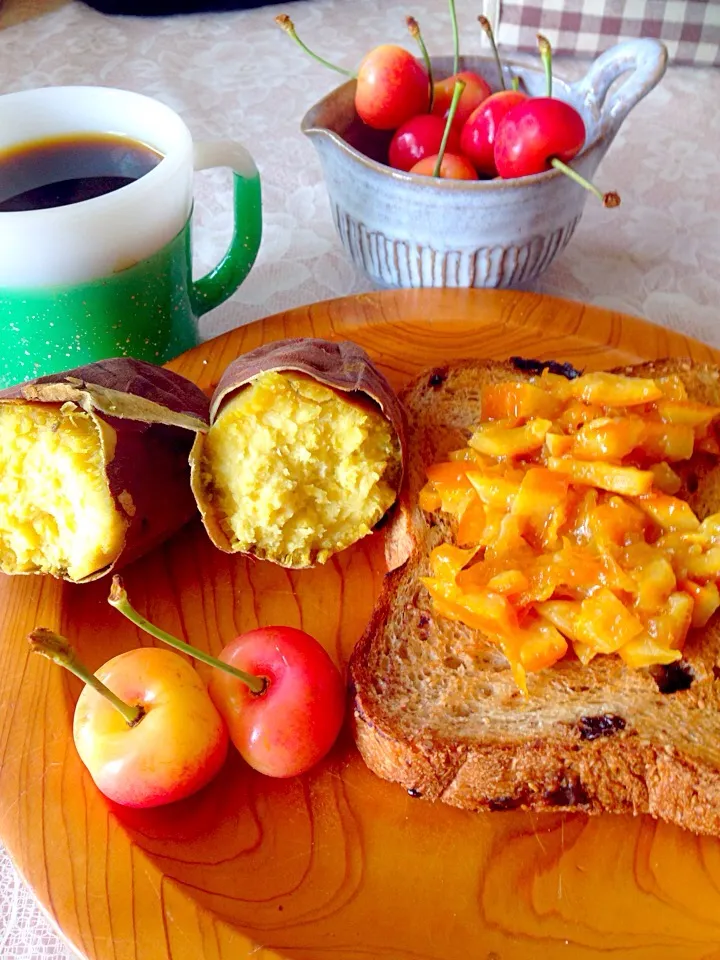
[0,358,210,583]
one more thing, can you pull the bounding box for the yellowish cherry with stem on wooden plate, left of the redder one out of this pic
[29,629,228,808]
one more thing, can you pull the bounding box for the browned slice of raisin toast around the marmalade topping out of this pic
[350,360,720,836]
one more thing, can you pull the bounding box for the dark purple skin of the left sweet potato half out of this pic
[0,357,210,581]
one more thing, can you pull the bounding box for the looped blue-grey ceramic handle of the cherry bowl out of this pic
[571,39,667,139]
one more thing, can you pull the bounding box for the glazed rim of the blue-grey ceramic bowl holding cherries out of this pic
[300,56,605,193]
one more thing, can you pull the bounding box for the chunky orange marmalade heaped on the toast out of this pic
[420,372,720,693]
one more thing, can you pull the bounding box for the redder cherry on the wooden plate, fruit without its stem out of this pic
[209,627,345,777]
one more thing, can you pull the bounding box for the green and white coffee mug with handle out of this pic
[0,86,262,387]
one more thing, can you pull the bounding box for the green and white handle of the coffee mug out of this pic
[190,140,262,317]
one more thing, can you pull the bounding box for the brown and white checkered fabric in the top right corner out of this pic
[484,0,720,67]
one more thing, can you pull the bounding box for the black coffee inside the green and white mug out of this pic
[0,133,162,212]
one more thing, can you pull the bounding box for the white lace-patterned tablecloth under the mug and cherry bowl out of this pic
[0,0,720,960]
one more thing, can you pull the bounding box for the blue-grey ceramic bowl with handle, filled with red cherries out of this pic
[276,10,667,287]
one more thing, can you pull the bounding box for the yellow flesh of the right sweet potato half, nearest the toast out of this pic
[203,372,400,567]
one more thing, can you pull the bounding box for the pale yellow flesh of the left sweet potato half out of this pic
[0,403,127,580]
